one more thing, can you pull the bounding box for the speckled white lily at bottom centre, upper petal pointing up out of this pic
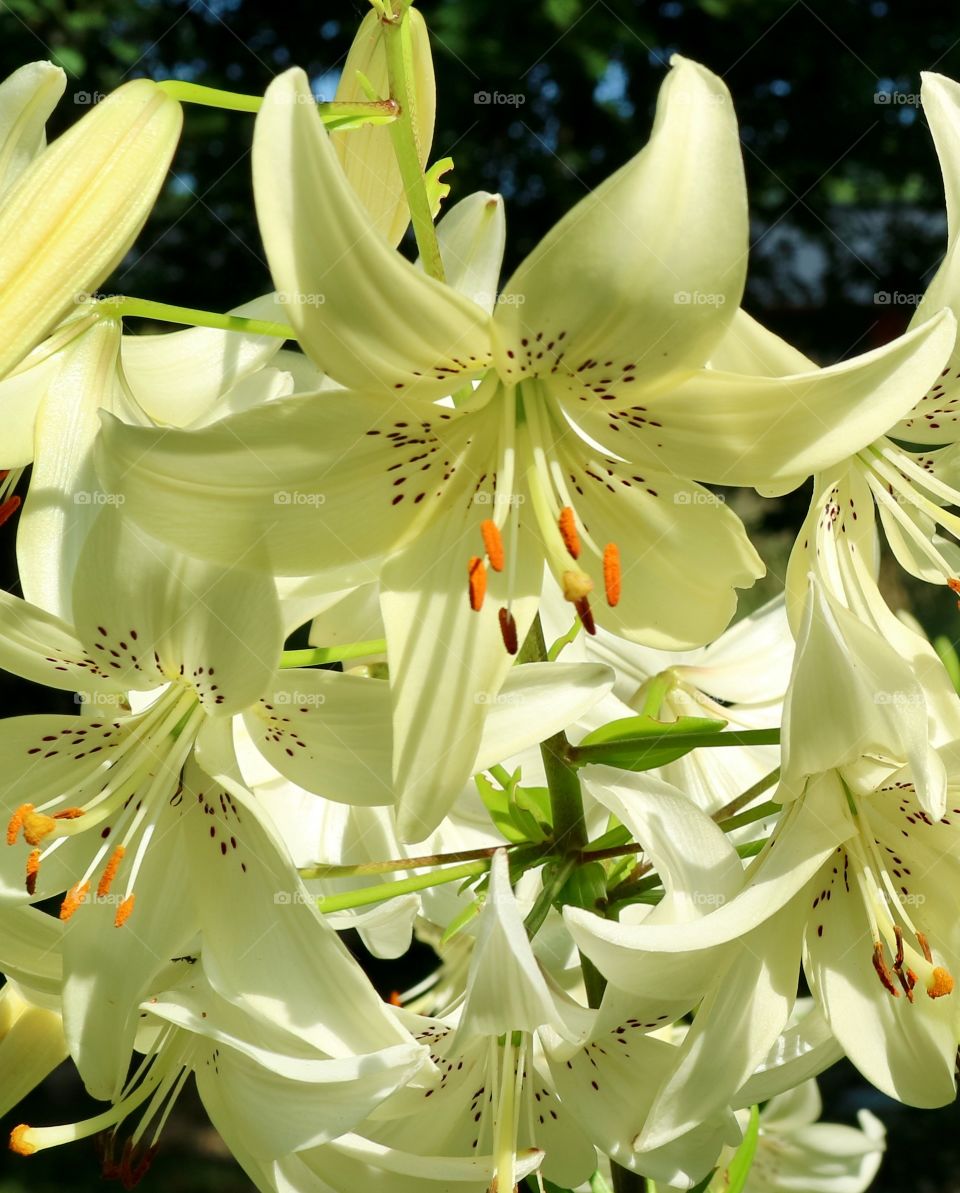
[361,853,736,1189]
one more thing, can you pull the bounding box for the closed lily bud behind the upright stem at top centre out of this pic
[330,8,436,246]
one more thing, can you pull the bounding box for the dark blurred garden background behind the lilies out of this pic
[0,0,960,1193]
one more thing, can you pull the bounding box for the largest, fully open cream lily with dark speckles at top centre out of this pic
[103,58,952,840]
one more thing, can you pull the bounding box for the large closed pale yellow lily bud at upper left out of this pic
[0,79,181,377]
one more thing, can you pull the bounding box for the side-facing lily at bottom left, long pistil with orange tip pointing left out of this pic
[10,957,427,1183]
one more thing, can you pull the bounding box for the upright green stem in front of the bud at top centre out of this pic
[383,6,444,282]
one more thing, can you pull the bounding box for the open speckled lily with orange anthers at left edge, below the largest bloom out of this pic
[0,509,434,1096]
